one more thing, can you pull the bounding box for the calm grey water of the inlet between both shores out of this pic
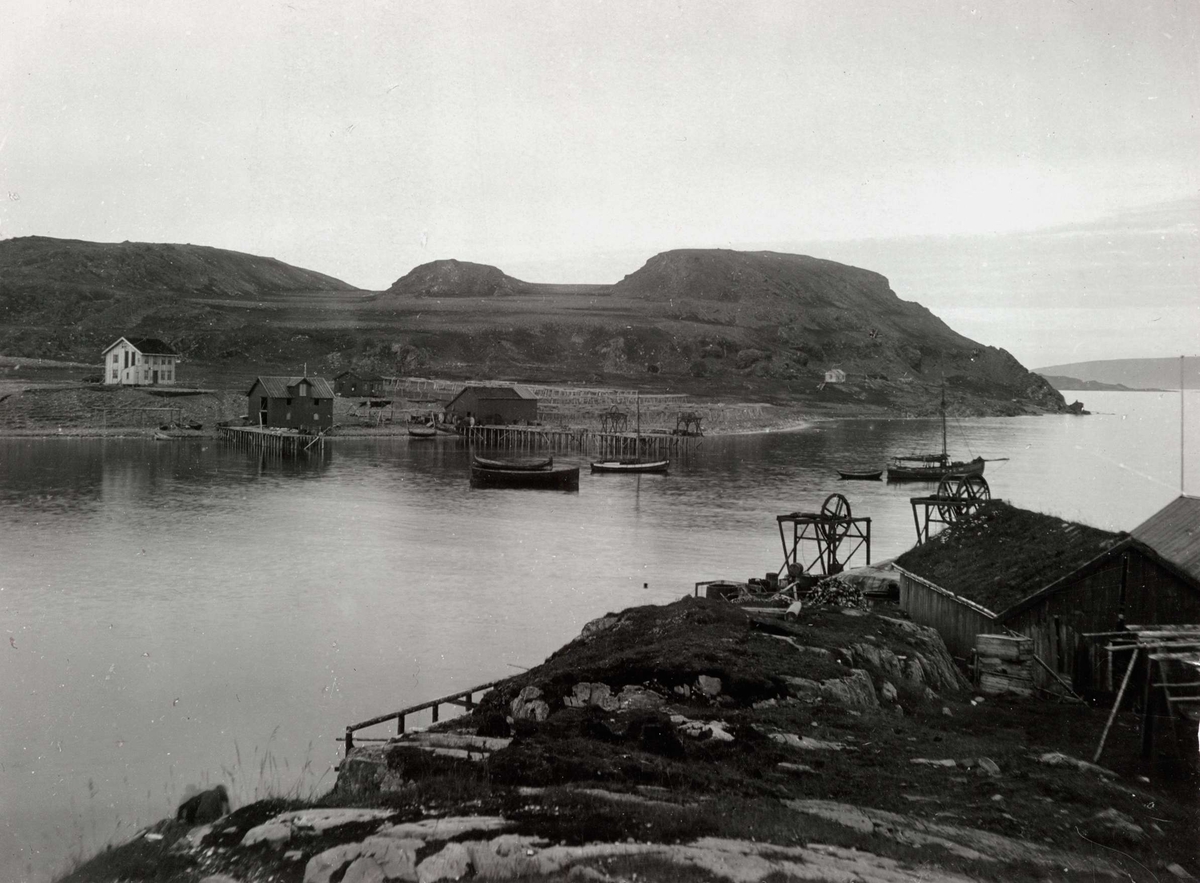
[0,394,1200,879]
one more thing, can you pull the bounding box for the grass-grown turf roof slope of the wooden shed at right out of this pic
[896,500,1120,613]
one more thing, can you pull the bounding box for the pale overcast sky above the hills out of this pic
[0,0,1200,367]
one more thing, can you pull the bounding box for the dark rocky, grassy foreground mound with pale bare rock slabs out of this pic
[66,599,1196,883]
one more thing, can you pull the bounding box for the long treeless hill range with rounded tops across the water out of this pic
[0,239,1063,414]
